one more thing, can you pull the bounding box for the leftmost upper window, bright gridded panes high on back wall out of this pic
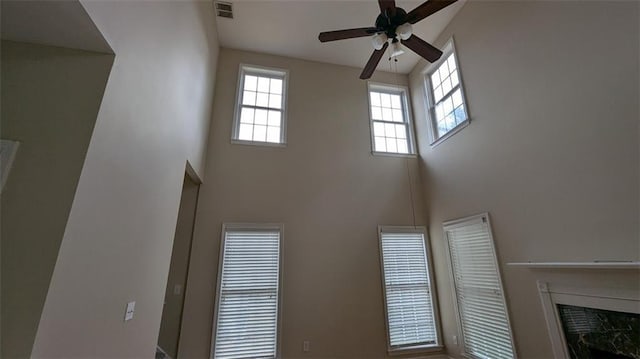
[232,65,287,144]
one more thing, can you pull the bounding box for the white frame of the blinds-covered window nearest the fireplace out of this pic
[443,212,518,359]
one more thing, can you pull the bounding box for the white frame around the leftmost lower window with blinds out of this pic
[209,223,284,359]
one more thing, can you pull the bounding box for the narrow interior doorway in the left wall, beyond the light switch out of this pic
[156,173,200,359]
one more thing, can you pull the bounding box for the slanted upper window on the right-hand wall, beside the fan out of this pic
[425,40,469,143]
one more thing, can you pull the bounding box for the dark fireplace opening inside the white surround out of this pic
[558,304,640,359]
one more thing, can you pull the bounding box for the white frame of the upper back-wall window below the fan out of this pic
[367,81,417,158]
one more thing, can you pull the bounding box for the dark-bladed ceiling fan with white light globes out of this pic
[318,0,457,80]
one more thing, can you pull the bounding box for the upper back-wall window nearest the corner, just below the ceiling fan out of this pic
[369,83,415,154]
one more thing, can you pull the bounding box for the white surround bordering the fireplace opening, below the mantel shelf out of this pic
[537,281,640,359]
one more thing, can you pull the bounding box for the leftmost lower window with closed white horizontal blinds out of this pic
[212,225,282,359]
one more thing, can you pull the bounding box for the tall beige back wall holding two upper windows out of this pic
[181,49,424,358]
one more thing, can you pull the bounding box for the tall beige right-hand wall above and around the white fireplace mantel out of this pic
[410,1,640,358]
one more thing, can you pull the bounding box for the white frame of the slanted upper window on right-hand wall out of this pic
[422,37,471,147]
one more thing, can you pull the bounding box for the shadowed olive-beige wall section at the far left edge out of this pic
[0,41,113,358]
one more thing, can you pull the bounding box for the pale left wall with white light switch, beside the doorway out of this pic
[33,1,218,358]
